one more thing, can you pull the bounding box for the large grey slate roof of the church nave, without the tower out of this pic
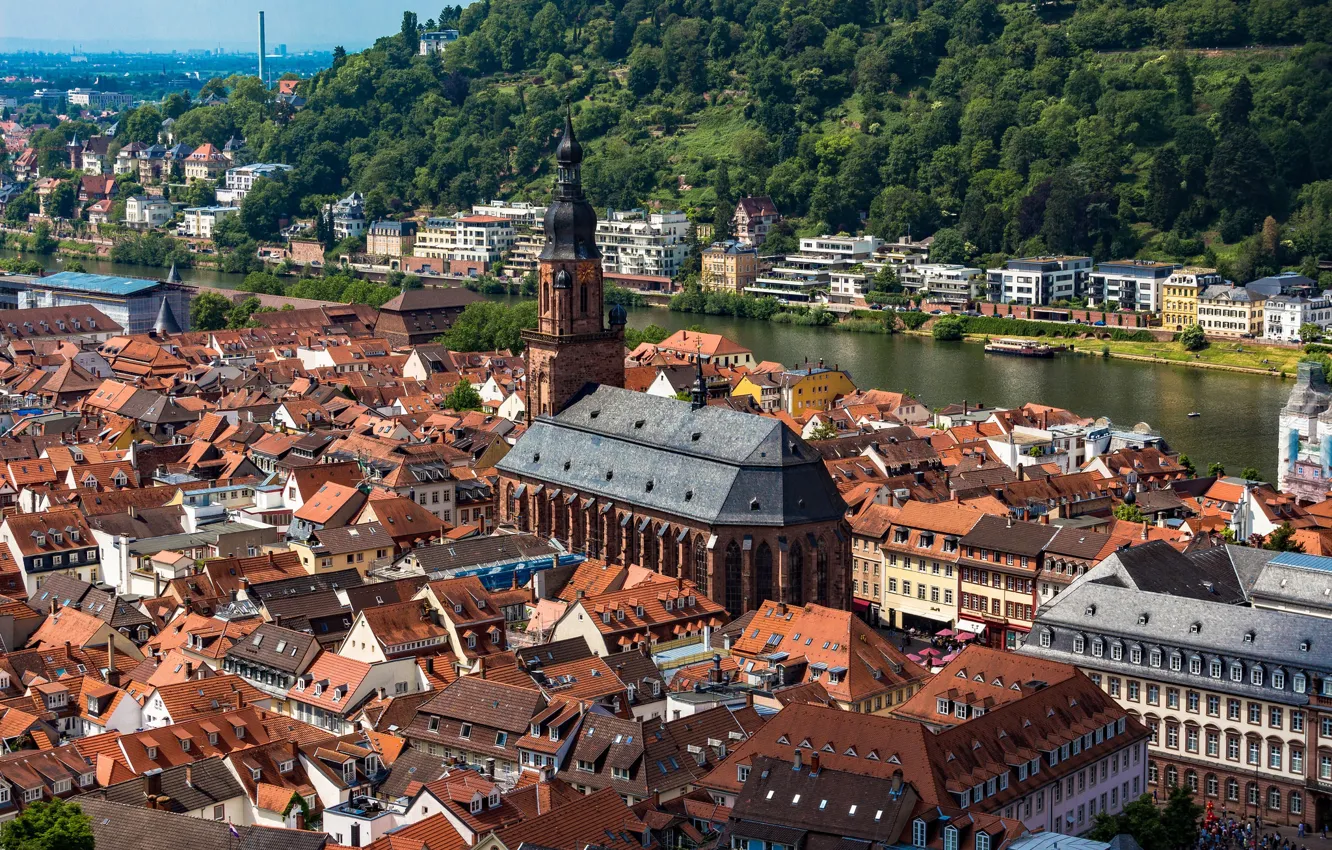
[498,386,846,526]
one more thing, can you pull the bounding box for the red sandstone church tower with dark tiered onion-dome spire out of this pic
[522,115,626,420]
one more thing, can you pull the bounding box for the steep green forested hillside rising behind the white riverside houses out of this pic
[143,0,1332,276]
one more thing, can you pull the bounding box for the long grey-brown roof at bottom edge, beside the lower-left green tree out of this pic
[79,797,328,850]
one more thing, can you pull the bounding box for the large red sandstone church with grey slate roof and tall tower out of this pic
[498,117,851,616]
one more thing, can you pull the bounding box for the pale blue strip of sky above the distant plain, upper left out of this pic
[0,0,428,52]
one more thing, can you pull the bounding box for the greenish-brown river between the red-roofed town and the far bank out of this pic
[0,252,1291,476]
